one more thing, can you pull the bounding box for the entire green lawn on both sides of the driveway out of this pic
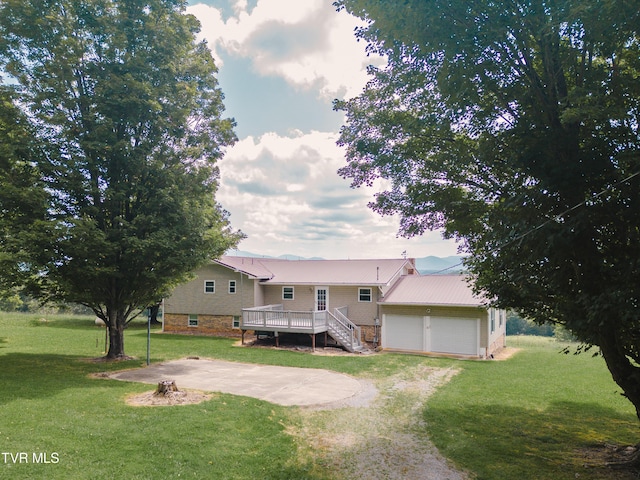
[0,314,638,480]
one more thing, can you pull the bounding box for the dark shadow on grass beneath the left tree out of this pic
[0,353,140,405]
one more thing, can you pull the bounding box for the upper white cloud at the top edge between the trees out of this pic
[188,0,380,99]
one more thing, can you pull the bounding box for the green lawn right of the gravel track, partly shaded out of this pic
[424,337,638,480]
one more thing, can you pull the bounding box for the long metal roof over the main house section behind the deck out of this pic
[217,256,413,286]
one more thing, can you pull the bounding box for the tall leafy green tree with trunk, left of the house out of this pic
[0,0,241,358]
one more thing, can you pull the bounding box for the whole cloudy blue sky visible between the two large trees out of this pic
[187,0,457,259]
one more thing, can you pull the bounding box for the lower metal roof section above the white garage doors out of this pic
[380,275,487,307]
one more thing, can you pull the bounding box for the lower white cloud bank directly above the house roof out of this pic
[218,132,456,258]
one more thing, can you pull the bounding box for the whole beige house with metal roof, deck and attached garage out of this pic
[163,256,506,357]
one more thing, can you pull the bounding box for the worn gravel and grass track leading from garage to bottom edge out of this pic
[288,365,469,480]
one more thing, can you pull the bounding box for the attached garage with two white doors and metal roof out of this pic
[378,275,506,357]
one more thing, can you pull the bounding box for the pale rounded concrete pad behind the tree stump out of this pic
[109,359,366,406]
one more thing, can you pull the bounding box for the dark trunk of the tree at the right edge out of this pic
[599,325,640,419]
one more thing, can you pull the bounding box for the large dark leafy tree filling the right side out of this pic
[336,0,640,417]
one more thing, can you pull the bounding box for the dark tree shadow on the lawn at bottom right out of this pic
[425,401,638,479]
